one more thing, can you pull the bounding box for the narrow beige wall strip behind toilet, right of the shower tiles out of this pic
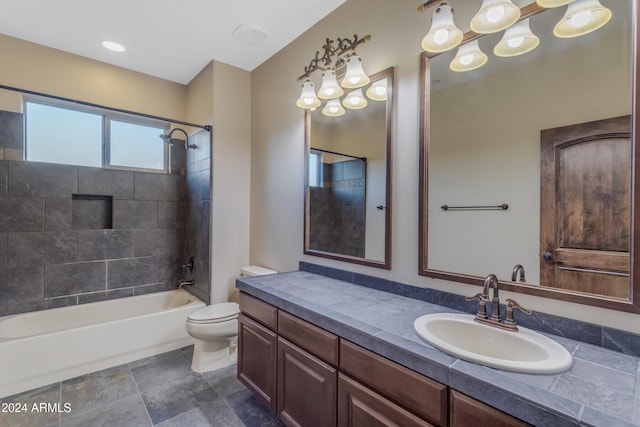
[211,62,251,303]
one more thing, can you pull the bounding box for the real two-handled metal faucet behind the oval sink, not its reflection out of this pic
[465,274,533,331]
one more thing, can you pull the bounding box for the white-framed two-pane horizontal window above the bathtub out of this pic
[25,100,169,172]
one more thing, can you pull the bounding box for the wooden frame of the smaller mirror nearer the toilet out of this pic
[304,67,395,270]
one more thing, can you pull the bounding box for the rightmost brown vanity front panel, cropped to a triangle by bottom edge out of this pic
[450,390,530,427]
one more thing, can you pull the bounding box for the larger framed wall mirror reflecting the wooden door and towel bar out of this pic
[419,0,640,312]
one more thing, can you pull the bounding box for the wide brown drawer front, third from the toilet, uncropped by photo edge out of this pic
[340,339,448,425]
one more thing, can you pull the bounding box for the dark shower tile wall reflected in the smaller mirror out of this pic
[309,160,366,257]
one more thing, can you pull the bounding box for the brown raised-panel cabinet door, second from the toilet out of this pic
[277,338,338,427]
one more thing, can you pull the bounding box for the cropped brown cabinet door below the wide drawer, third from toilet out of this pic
[338,374,432,427]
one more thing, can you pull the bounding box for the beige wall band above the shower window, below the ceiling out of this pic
[0,34,187,120]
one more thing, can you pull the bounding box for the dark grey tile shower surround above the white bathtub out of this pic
[0,112,215,316]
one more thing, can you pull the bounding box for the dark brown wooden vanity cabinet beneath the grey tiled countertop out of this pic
[238,292,529,427]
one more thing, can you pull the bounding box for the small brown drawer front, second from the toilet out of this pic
[278,310,338,366]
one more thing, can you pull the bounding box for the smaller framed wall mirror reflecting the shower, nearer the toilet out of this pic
[304,68,394,269]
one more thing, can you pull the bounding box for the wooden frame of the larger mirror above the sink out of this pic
[418,0,640,313]
